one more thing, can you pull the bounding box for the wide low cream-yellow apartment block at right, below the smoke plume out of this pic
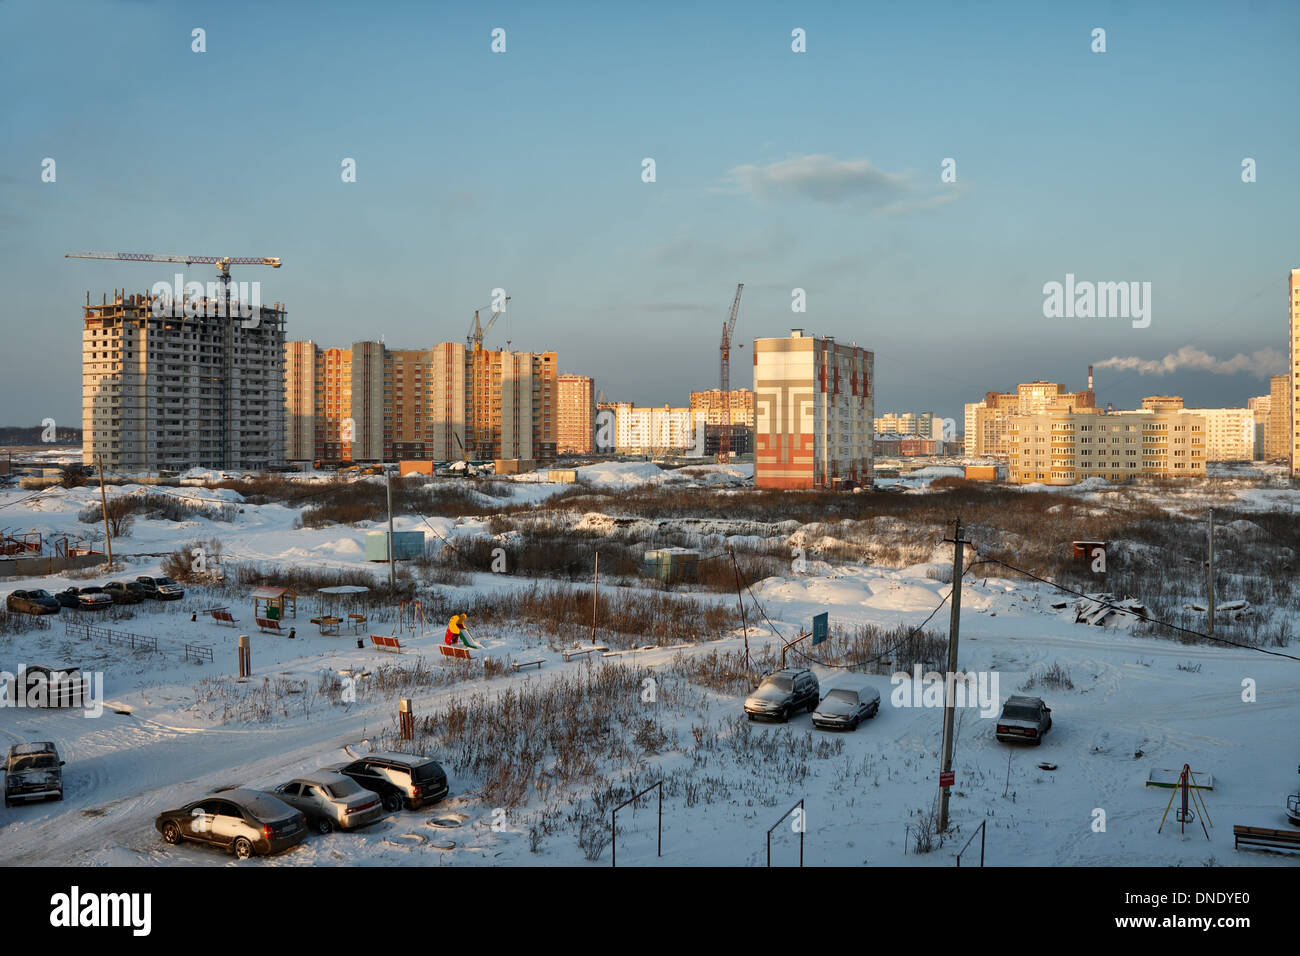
[1008,406,1205,485]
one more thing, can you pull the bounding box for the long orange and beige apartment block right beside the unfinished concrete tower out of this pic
[283,342,558,463]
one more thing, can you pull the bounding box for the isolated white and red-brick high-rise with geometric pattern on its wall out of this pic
[754,329,875,489]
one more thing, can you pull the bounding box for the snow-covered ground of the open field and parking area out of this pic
[0,463,1300,866]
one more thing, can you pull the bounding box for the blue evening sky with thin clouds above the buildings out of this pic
[0,0,1300,424]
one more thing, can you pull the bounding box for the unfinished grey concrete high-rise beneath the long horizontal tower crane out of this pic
[82,290,285,473]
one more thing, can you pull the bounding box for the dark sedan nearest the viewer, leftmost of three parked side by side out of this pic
[153,788,307,860]
